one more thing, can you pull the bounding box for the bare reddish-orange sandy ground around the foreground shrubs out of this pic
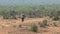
[0,17,60,34]
